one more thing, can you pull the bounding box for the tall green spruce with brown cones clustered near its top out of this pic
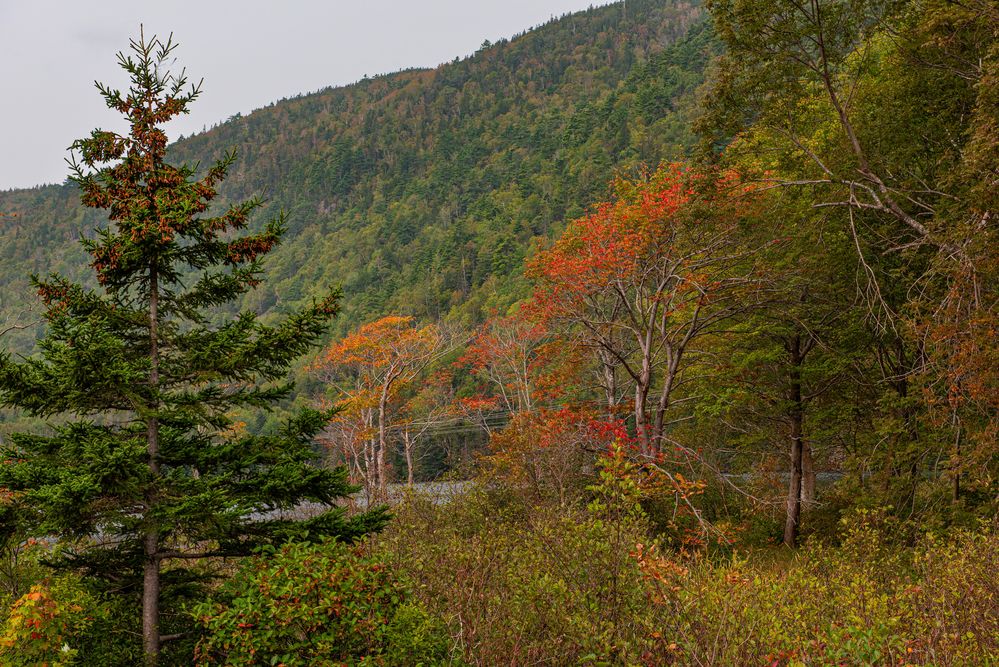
[0,30,386,664]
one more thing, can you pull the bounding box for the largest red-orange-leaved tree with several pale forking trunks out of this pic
[528,164,764,457]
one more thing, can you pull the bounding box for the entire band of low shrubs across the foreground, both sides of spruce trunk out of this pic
[0,472,999,667]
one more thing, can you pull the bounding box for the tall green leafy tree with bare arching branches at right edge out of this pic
[701,0,999,515]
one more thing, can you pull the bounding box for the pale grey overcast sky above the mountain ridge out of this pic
[0,0,608,190]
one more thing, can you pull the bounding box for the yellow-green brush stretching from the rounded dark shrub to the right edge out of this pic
[374,486,999,667]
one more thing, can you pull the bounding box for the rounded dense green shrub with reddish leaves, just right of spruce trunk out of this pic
[193,541,446,667]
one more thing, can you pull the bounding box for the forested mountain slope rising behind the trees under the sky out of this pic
[0,0,717,348]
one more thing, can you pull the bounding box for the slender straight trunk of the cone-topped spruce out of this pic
[142,266,160,667]
